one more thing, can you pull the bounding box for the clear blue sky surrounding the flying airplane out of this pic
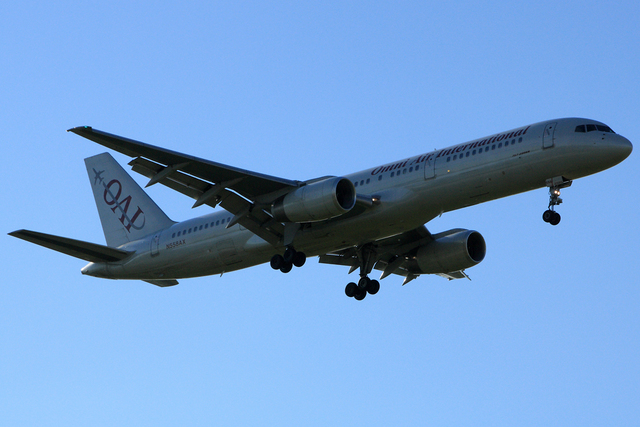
[0,0,640,426]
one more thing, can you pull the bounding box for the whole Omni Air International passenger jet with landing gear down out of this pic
[9,118,633,301]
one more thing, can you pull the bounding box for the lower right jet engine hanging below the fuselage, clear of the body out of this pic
[416,230,487,274]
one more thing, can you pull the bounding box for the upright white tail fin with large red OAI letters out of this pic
[84,153,174,247]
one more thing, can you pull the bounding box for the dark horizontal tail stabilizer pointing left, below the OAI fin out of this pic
[9,230,133,262]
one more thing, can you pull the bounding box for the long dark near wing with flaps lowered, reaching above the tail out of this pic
[69,126,302,245]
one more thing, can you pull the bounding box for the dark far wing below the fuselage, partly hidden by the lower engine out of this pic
[319,225,469,286]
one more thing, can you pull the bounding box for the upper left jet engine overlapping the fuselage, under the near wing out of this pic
[271,177,356,222]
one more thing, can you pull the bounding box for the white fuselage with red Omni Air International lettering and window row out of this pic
[82,119,631,280]
